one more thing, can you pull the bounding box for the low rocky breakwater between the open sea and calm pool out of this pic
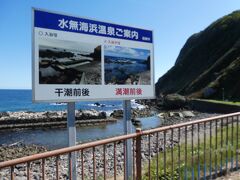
[0,110,117,130]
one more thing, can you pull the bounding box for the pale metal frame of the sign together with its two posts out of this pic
[32,8,155,180]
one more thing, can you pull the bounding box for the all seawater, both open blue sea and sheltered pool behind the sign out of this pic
[0,90,161,149]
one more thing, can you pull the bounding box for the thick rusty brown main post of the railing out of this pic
[136,128,142,180]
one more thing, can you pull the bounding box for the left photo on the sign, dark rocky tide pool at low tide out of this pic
[39,39,101,84]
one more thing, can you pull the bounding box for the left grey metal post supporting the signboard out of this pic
[67,102,77,180]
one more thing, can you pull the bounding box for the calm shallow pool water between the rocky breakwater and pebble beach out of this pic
[0,116,161,150]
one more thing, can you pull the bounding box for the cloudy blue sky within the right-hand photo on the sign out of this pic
[104,45,150,60]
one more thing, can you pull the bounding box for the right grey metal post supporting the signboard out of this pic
[123,100,132,179]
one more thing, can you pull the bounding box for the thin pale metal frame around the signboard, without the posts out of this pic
[32,8,155,102]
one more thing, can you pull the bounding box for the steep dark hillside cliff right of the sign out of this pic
[156,11,240,100]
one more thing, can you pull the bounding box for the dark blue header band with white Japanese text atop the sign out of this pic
[34,10,152,43]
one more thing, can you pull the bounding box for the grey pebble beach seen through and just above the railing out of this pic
[0,112,220,179]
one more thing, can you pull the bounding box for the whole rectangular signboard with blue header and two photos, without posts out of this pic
[32,9,155,102]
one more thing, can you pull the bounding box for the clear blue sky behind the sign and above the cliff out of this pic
[0,0,240,89]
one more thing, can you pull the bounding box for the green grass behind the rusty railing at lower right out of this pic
[143,124,240,180]
